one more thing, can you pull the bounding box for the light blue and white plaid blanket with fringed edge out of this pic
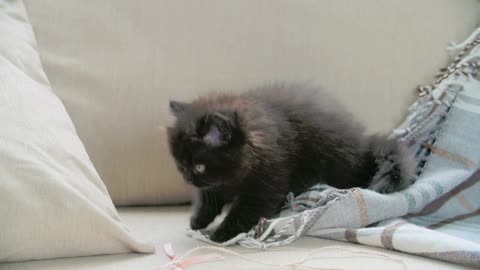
[189,28,480,268]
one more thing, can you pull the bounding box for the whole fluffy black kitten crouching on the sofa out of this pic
[168,85,414,242]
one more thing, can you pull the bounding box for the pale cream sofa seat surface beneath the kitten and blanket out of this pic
[0,206,466,270]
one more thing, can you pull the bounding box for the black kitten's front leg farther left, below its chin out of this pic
[190,189,225,230]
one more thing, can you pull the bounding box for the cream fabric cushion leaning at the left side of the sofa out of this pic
[0,1,153,262]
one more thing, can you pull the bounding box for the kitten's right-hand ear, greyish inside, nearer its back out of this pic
[202,112,237,147]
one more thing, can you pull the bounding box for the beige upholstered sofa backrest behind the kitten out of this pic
[20,0,480,205]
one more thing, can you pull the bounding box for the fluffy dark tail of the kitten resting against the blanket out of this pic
[368,136,415,193]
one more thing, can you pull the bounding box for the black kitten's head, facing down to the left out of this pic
[167,101,246,188]
